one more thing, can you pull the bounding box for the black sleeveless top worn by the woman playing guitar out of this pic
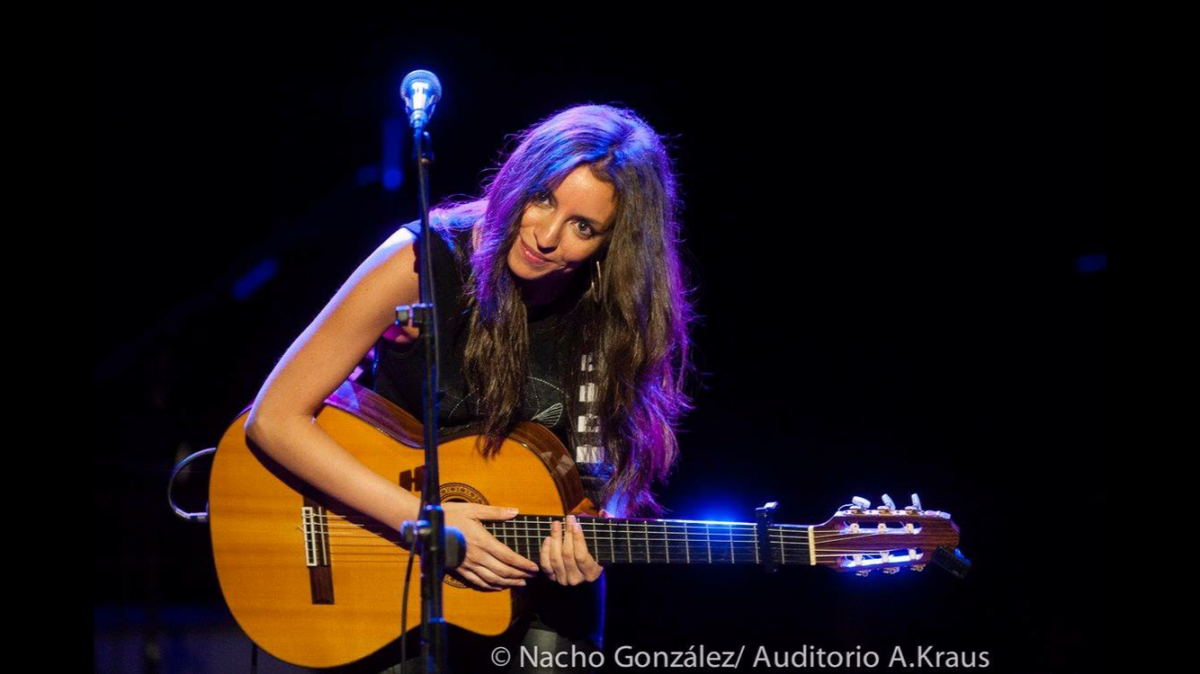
[373,221,611,507]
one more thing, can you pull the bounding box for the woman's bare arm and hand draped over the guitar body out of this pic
[246,223,538,589]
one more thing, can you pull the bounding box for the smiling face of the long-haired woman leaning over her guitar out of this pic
[509,164,617,299]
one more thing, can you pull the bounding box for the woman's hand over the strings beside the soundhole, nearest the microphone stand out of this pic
[442,501,541,590]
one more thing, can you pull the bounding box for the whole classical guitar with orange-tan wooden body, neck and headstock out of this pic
[209,383,965,667]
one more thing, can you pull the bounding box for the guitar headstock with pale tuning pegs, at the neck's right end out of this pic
[811,494,971,578]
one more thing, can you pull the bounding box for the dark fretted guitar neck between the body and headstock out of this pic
[484,514,812,566]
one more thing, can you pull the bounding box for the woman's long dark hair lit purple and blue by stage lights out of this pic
[432,106,695,513]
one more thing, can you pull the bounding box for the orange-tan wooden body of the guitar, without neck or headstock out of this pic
[209,384,583,667]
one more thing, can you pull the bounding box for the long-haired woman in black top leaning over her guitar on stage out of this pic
[247,106,692,669]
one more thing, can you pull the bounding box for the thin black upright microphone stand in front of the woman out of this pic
[396,120,453,674]
